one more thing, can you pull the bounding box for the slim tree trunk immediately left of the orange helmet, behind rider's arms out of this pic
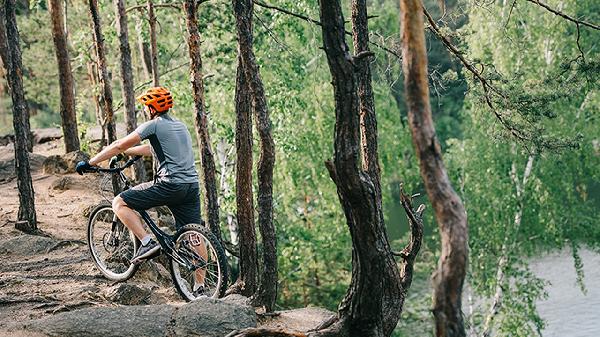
[114,0,146,183]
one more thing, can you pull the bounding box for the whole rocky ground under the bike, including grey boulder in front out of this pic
[0,131,331,336]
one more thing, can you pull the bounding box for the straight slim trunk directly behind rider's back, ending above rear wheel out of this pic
[183,0,221,241]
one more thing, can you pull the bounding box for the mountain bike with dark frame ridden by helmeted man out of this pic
[82,156,228,301]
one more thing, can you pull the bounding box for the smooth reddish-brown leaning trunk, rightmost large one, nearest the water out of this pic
[400,0,468,336]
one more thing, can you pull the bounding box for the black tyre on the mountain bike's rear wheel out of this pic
[169,224,228,302]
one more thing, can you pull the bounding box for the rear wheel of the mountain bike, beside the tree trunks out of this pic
[169,224,228,301]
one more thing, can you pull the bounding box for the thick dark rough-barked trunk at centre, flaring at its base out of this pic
[315,0,414,336]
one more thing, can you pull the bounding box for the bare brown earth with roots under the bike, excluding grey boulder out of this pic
[0,135,328,329]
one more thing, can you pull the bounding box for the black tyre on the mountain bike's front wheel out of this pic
[87,202,140,282]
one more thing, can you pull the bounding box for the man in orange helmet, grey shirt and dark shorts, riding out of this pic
[76,87,207,291]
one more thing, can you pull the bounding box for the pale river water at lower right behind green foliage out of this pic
[530,245,600,337]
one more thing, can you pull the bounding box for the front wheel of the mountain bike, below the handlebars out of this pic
[87,203,139,282]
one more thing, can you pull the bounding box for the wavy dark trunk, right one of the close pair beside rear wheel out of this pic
[233,0,277,311]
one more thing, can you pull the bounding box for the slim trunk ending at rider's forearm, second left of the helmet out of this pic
[89,0,117,143]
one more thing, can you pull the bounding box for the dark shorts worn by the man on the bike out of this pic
[120,181,202,229]
